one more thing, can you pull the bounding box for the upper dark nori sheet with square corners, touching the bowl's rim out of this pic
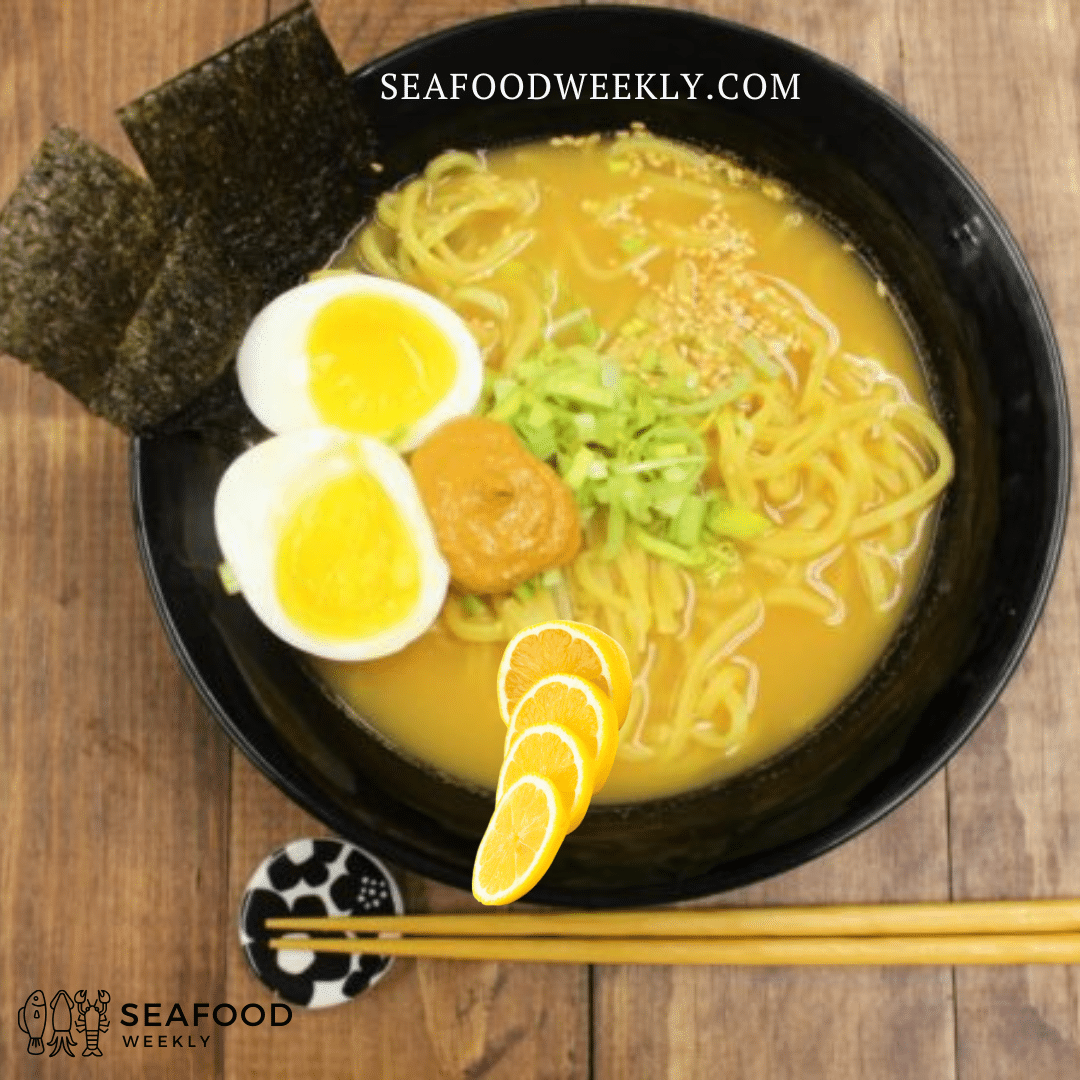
[120,6,372,300]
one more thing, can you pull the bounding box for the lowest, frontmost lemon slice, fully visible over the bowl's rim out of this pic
[473,774,566,904]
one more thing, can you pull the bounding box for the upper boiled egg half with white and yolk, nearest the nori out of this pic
[243,272,483,450]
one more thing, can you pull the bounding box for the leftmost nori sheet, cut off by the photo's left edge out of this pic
[0,129,171,404]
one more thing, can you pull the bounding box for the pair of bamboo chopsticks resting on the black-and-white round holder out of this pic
[266,900,1080,964]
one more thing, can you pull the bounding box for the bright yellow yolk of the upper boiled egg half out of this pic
[307,294,457,435]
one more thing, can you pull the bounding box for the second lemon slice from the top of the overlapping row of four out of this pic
[503,674,619,792]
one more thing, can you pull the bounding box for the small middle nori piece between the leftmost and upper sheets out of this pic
[96,212,259,431]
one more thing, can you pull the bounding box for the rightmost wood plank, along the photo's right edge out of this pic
[901,0,1080,1080]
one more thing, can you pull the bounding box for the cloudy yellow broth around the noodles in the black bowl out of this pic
[315,132,931,802]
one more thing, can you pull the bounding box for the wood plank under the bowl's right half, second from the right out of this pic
[593,0,955,1080]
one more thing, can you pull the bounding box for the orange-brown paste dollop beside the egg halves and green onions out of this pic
[410,416,581,595]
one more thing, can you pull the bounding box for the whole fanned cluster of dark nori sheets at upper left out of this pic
[0,5,384,437]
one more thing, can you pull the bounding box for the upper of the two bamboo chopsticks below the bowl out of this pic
[266,900,1080,937]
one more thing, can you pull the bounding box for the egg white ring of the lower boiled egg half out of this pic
[214,428,450,660]
